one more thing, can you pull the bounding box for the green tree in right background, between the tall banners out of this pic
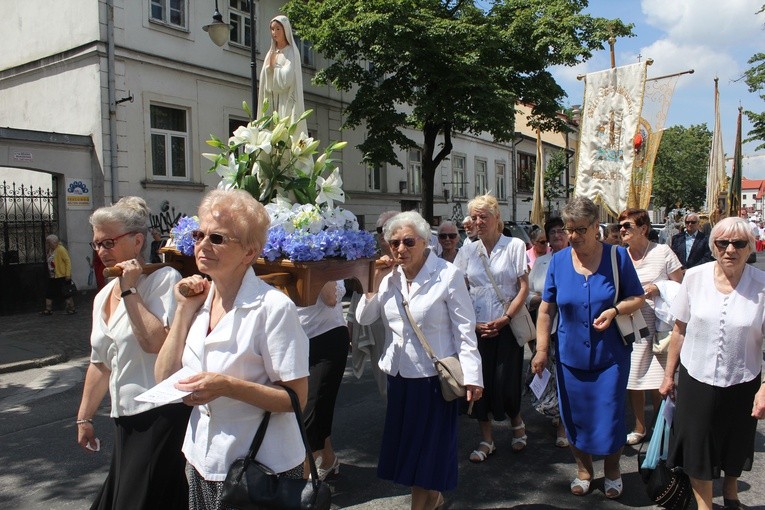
[653,124,712,211]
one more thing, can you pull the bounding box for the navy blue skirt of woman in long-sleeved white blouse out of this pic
[377,375,460,491]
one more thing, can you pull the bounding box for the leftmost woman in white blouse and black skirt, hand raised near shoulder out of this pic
[77,197,190,509]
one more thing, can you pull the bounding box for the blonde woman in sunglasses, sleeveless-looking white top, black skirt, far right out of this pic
[659,218,765,510]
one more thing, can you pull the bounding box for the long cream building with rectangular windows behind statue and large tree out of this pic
[0,0,576,304]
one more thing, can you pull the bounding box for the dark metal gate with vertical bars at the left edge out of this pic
[0,176,59,313]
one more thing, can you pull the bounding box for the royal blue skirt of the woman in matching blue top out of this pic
[556,362,630,455]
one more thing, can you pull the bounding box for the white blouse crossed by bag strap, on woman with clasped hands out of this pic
[454,235,526,323]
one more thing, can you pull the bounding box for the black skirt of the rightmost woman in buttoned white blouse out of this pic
[667,365,760,480]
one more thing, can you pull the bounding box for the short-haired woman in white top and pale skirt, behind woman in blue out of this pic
[618,208,683,445]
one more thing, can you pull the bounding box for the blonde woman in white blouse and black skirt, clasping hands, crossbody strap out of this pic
[454,195,529,462]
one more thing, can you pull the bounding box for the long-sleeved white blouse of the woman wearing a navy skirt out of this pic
[356,252,483,387]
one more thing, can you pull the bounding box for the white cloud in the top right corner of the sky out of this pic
[641,0,763,48]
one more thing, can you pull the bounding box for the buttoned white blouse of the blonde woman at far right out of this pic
[672,261,765,388]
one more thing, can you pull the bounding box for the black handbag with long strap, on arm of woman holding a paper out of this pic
[221,387,332,510]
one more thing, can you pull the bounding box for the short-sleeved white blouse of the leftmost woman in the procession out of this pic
[90,267,181,418]
